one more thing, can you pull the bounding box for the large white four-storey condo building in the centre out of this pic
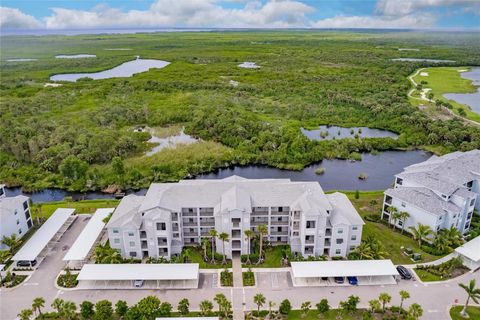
[107,176,364,258]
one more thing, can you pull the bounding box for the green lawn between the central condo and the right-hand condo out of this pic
[344,191,441,264]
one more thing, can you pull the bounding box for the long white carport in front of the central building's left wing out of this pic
[77,263,199,289]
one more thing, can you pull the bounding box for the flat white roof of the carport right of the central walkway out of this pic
[291,260,398,278]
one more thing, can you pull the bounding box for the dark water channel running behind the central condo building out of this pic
[6,150,431,203]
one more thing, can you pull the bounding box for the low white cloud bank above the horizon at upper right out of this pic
[312,14,436,29]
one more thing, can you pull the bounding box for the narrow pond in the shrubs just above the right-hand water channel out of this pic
[300,126,398,140]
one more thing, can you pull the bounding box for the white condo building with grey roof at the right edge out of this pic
[382,150,480,233]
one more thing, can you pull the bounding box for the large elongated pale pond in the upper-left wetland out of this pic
[50,59,170,82]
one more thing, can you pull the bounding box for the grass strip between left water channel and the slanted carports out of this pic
[32,199,120,218]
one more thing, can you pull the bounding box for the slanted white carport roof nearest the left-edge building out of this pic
[12,208,75,261]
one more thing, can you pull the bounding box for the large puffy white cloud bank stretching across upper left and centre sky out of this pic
[44,0,314,29]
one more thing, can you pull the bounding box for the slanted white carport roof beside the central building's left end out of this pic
[63,208,115,261]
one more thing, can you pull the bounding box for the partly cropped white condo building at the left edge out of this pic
[0,185,33,250]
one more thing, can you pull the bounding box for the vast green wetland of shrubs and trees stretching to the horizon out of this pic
[0,30,480,191]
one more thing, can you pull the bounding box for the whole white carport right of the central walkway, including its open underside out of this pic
[291,260,399,287]
